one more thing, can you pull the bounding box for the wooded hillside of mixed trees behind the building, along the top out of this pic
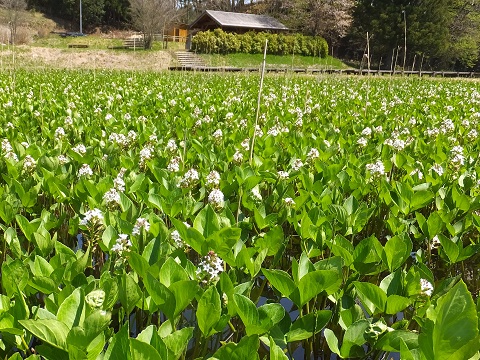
[12,0,480,70]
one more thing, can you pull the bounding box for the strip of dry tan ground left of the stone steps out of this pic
[1,46,172,71]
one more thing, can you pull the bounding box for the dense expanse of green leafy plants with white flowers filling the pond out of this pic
[0,71,480,360]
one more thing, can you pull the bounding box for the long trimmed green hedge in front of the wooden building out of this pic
[192,29,328,58]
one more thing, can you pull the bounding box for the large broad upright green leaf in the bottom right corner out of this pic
[427,280,480,360]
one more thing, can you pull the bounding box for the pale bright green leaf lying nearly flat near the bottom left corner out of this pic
[19,319,70,350]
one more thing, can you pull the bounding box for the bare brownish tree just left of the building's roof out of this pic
[130,0,180,49]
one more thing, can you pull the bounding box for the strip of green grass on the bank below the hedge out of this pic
[199,53,348,69]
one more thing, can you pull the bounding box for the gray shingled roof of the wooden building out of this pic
[190,10,288,30]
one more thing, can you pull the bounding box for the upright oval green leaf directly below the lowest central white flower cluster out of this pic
[197,286,222,338]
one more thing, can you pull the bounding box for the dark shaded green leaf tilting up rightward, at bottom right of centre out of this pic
[285,310,332,342]
